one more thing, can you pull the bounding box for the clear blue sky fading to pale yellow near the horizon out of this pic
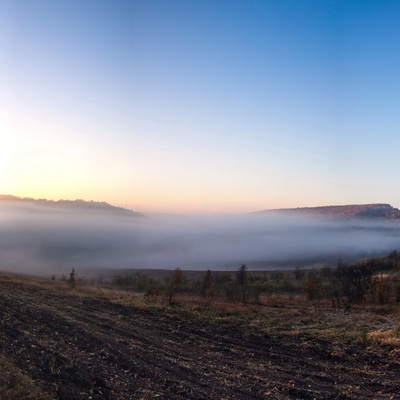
[0,0,400,213]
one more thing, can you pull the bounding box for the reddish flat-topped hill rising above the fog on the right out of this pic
[260,204,400,219]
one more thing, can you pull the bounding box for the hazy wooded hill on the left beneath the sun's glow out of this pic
[0,195,143,217]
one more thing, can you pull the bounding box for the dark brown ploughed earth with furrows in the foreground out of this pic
[0,276,400,400]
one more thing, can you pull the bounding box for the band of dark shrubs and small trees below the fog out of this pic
[104,251,400,309]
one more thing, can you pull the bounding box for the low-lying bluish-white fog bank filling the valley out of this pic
[0,203,400,274]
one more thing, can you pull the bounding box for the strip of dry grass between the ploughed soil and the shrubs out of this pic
[2,275,400,352]
